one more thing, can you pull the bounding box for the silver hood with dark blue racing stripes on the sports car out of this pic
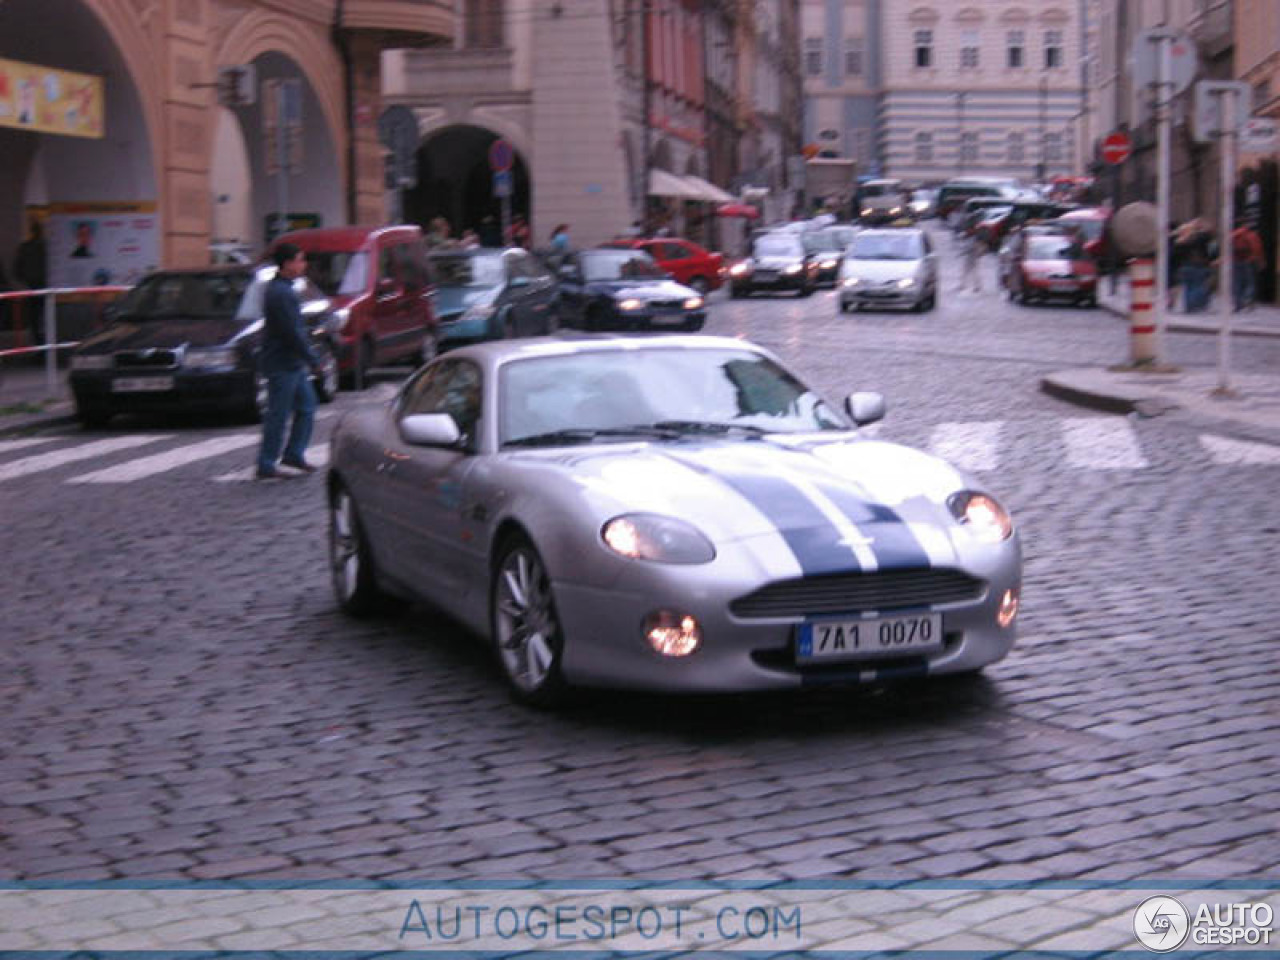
[512,434,968,575]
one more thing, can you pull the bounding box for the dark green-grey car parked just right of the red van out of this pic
[430,247,559,351]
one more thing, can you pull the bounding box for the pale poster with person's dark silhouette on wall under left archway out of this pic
[45,204,160,287]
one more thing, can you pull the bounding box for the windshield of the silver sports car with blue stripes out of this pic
[499,347,849,444]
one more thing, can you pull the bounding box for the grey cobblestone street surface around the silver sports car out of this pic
[0,224,1280,882]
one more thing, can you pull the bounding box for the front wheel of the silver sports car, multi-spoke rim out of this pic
[489,535,566,707]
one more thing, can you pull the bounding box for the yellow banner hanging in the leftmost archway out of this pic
[0,60,102,138]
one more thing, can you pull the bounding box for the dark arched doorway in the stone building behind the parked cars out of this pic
[403,125,530,244]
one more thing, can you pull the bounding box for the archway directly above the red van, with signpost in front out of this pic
[210,51,344,247]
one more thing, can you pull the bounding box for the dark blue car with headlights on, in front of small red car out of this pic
[561,247,707,330]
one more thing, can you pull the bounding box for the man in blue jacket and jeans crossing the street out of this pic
[257,243,317,480]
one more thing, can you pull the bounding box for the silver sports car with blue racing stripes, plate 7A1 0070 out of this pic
[328,335,1021,703]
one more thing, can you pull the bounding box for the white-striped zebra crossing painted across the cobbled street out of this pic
[0,417,1280,488]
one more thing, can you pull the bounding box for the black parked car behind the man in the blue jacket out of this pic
[69,266,338,426]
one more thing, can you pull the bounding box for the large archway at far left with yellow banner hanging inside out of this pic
[0,0,164,285]
